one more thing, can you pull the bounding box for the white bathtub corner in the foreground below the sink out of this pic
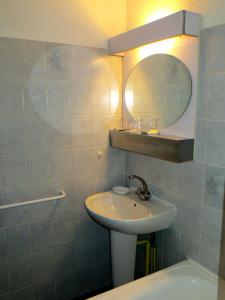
[90,260,219,300]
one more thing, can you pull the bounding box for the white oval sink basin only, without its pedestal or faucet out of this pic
[85,192,175,234]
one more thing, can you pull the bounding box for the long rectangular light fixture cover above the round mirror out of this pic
[108,10,201,55]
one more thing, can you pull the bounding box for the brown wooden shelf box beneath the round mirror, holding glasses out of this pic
[109,129,194,163]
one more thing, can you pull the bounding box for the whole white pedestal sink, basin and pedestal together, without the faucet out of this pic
[85,192,175,287]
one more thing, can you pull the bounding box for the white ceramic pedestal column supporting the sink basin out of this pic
[110,230,137,287]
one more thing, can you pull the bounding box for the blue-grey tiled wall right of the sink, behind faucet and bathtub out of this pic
[127,25,225,272]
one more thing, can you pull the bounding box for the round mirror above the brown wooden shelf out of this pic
[125,54,192,129]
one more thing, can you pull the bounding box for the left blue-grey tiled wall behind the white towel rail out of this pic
[0,38,124,300]
